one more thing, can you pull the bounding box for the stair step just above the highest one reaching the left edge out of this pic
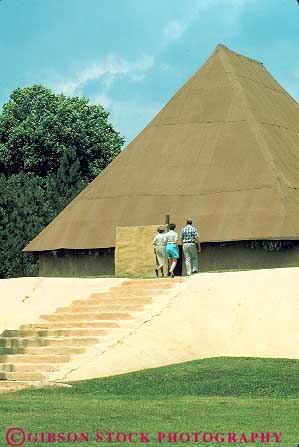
[20,321,119,334]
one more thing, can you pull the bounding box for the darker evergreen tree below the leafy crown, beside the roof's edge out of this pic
[0,156,86,278]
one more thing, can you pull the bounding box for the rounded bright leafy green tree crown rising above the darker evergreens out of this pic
[0,85,124,181]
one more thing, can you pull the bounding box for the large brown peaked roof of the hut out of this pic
[25,45,299,251]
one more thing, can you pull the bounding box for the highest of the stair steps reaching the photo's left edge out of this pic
[2,328,108,337]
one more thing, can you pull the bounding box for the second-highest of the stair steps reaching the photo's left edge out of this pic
[0,337,99,349]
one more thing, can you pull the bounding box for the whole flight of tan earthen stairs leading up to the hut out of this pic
[0,278,182,393]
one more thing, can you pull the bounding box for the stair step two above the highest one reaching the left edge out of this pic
[39,312,133,322]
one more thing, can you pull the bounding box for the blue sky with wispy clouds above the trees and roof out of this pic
[0,0,299,143]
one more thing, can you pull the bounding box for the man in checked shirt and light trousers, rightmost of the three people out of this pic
[181,219,201,276]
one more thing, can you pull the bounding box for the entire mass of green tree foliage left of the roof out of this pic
[0,85,123,278]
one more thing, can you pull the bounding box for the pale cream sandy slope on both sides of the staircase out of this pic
[0,268,299,381]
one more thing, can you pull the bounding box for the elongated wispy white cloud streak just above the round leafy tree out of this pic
[54,54,154,96]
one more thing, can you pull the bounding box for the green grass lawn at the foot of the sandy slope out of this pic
[0,358,299,447]
